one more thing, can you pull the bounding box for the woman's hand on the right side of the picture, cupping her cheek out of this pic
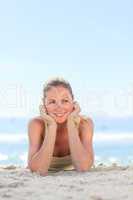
[68,102,81,127]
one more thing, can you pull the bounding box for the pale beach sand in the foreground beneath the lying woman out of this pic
[0,165,133,200]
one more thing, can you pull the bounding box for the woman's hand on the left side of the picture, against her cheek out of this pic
[39,105,57,127]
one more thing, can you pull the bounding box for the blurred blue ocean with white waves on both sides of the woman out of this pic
[0,117,133,166]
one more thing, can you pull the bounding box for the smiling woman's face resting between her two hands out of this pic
[44,86,74,123]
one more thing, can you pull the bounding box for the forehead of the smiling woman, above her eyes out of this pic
[46,86,72,98]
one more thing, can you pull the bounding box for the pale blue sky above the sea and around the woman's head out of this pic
[0,0,133,116]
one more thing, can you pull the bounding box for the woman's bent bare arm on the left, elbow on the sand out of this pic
[28,120,56,175]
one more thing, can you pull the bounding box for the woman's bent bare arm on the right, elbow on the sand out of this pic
[68,117,94,171]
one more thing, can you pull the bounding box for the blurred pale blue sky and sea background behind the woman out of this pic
[0,0,133,166]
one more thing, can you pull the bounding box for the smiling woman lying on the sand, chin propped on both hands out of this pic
[28,78,94,175]
